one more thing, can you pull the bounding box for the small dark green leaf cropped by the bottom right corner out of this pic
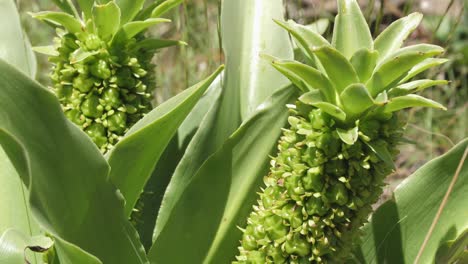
[435,229,468,264]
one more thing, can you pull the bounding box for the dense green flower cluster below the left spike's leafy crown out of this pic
[50,32,154,152]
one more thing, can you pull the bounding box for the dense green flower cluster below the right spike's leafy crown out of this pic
[238,107,402,264]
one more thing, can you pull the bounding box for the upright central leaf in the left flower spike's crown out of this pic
[92,1,121,41]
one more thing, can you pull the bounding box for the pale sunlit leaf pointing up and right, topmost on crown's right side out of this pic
[374,13,422,62]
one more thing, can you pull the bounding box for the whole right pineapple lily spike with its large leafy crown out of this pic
[234,0,447,264]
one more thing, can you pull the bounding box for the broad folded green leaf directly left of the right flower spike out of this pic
[149,87,296,263]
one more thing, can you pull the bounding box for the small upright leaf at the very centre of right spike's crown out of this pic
[350,48,379,83]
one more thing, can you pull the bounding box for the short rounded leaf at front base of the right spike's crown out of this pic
[340,83,374,117]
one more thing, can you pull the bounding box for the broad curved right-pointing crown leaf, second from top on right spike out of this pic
[366,44,444,96]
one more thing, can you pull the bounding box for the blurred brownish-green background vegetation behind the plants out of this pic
[17,0,468,201]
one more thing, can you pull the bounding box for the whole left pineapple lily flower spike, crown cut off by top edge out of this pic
[32,0,184,153]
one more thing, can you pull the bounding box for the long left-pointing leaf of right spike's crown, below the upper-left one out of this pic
[272,60,336,103]
